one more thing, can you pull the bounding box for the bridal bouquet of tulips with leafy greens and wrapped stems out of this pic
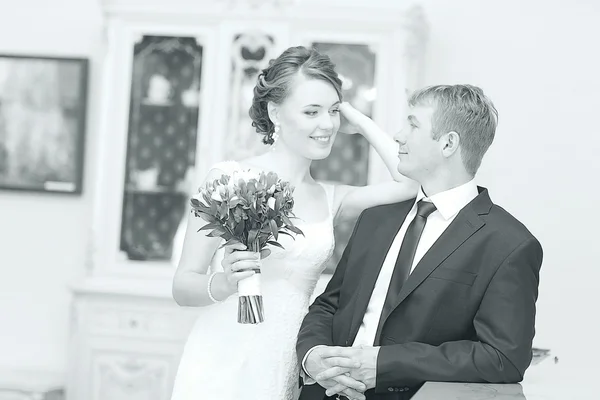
[191,171,303,324]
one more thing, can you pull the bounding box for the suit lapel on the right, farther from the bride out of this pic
[380,187,492,334]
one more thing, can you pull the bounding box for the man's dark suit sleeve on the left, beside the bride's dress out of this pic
[296,210,367,360]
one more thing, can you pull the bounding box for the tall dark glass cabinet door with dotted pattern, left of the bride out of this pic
[120,35,203,261]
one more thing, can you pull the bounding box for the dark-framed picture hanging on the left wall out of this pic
[0,54,88,194]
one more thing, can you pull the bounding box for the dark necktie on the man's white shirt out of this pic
[375,200,436,341]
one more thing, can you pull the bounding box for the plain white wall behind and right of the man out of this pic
[423,0,600,368]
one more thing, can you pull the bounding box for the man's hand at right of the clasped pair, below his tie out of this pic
[315,346,380,393]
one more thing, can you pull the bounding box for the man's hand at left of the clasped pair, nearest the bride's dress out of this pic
[304,346,366,400]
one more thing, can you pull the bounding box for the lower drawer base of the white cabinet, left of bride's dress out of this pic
[67,279,196,400]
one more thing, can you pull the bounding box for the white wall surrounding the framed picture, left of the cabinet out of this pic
[0,0,102,371]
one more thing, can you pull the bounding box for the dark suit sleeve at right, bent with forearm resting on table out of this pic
[375,238,543,393]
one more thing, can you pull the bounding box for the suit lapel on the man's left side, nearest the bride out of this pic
[349,199,414,340]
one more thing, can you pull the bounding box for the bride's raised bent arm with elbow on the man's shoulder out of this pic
[334,103,419,224]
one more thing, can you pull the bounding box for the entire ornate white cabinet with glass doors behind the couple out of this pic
[67,0,427,400]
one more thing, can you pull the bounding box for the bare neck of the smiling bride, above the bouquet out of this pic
[259,144,312,186]
